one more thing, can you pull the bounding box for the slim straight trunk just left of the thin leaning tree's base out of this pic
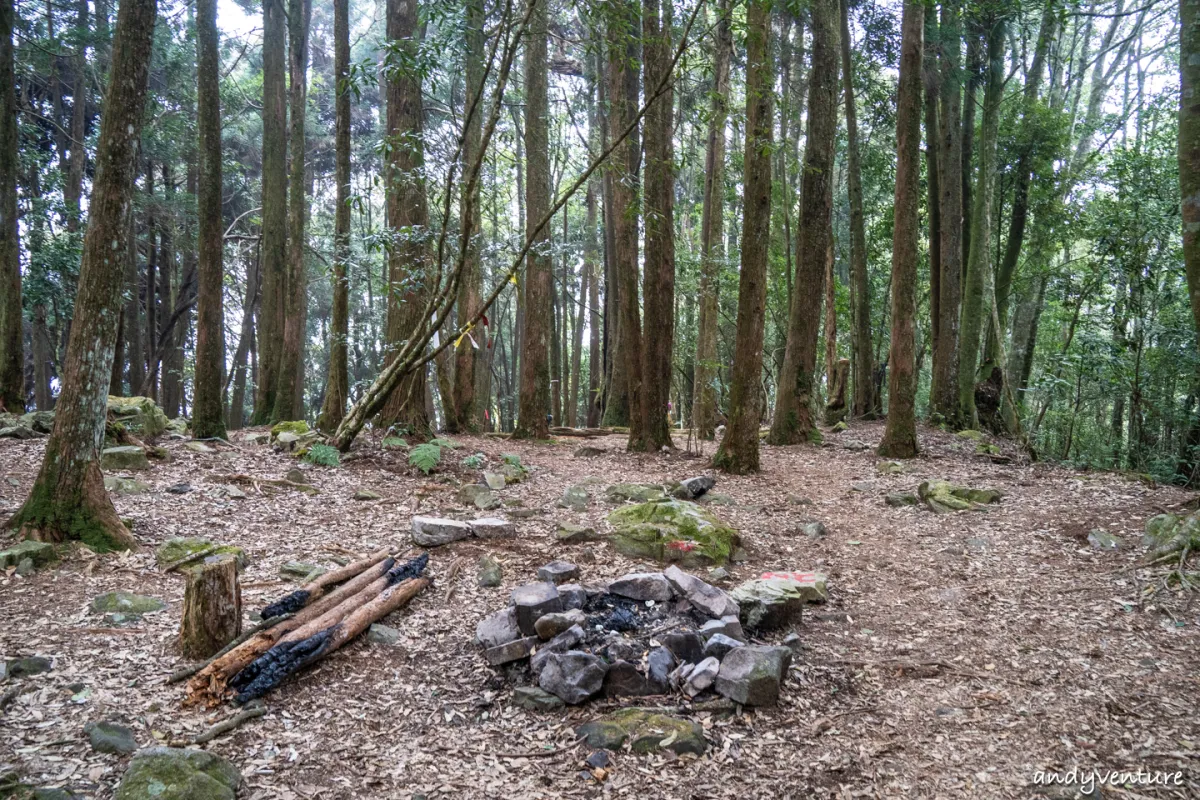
[317,0,353,433]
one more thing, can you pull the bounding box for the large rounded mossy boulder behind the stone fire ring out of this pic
[608,499,742,566]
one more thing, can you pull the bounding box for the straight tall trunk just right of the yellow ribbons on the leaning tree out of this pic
[512,0,554,439]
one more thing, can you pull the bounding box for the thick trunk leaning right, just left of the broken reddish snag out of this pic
[768,0,841,445]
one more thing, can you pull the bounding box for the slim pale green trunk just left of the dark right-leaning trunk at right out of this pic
[959,18,1004,427]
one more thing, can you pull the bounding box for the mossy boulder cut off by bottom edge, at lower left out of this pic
[113,747,241,800]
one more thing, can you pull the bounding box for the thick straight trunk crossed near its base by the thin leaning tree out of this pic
[379,0,431,435]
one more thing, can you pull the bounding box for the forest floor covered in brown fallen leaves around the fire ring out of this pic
[0,423,1200,800]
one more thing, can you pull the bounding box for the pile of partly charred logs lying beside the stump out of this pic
[184,551,432,705]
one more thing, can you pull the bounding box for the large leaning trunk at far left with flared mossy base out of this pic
[8,0,157,551]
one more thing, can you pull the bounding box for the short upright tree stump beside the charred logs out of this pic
[179,555,241,658]
